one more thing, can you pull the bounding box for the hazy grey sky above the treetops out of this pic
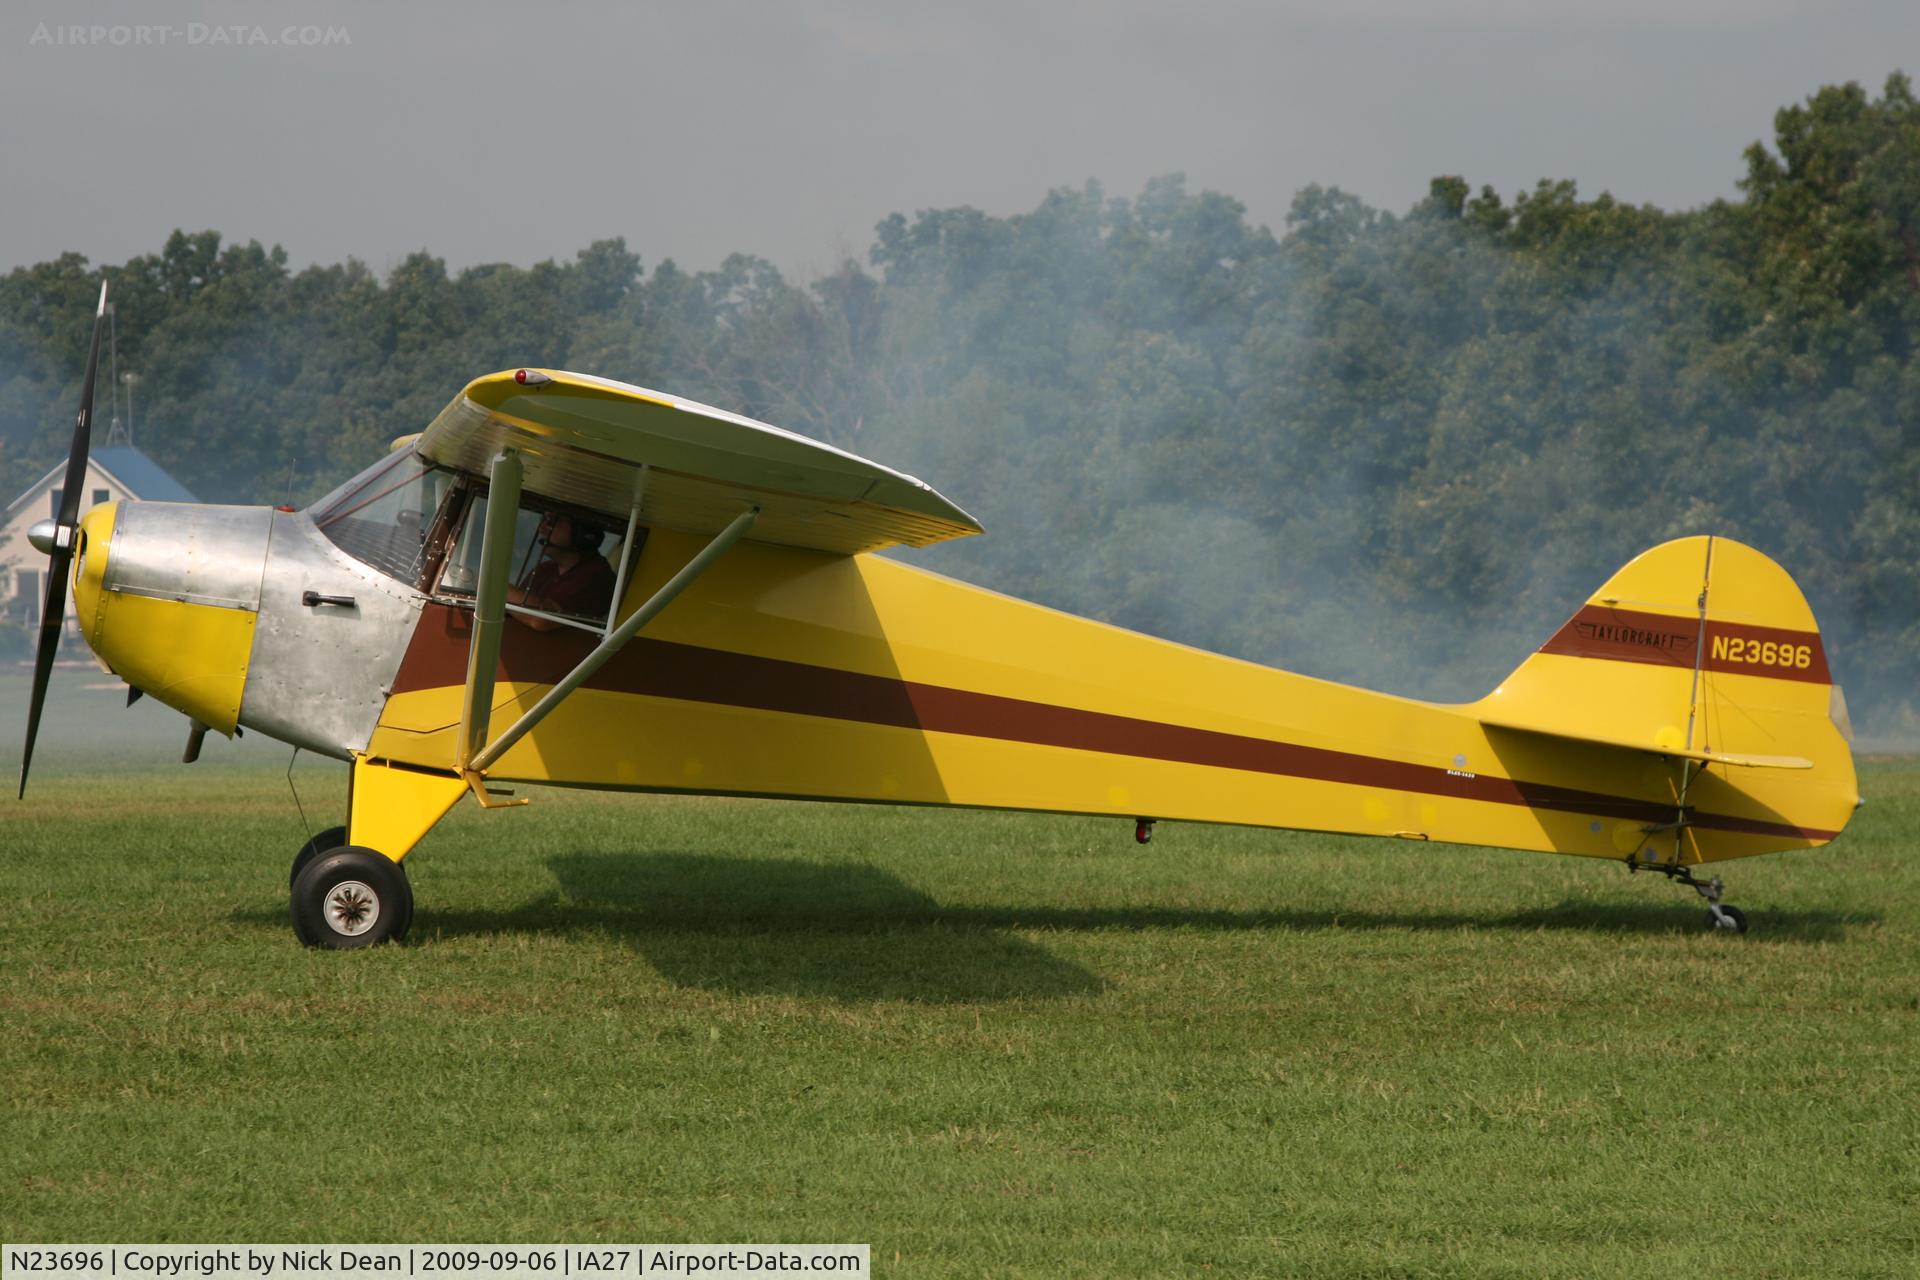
[0,0,1920,274]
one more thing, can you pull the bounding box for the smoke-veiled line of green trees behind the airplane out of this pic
[0,75,1920,733]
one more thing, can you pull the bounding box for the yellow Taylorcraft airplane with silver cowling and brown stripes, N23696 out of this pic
[21,290,1859,948]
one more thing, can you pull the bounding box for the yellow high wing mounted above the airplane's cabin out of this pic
[415,368,981,555]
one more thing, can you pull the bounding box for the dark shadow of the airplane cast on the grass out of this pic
[318,852,1876,1004]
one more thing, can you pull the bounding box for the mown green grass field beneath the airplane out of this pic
[0,677,1920,1276]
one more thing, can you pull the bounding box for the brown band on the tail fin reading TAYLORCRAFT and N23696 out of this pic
[1540,604,1834,685]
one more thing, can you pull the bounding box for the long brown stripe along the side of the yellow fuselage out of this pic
[394,604,1837,841]
